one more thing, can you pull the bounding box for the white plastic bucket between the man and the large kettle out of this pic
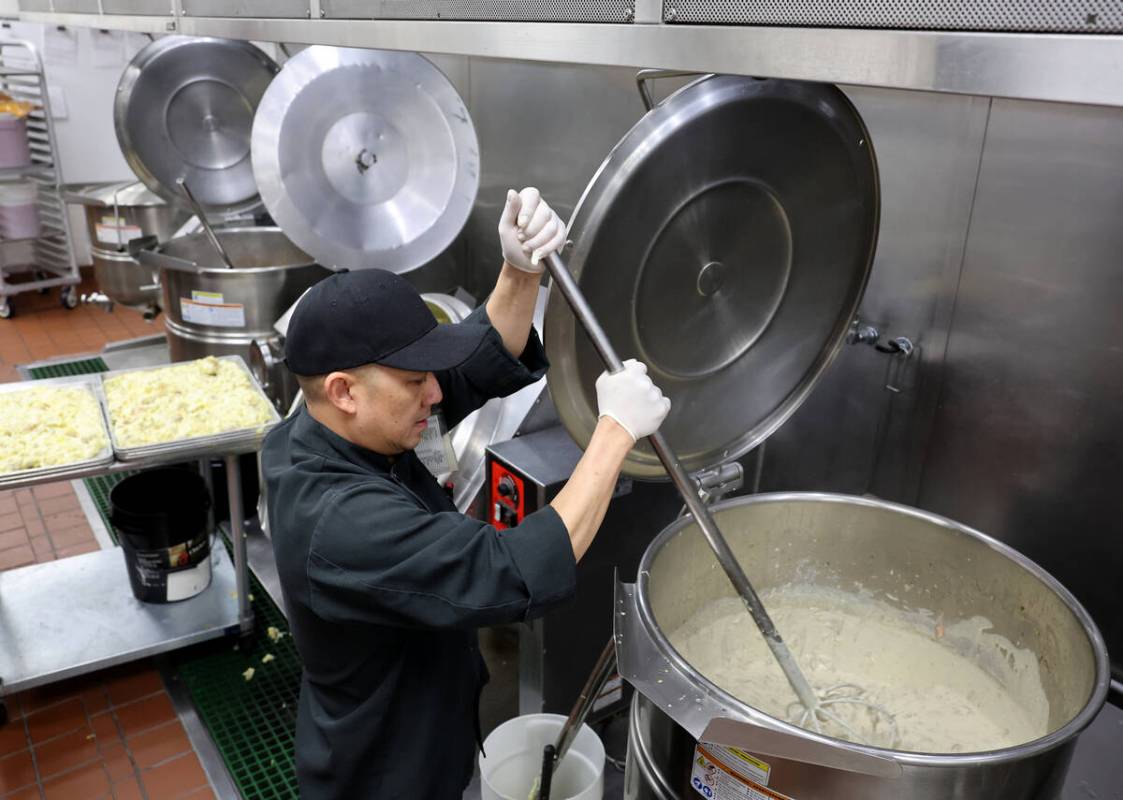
[480,713,604,800]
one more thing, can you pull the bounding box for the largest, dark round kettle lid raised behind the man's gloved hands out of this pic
[545,76,879,479]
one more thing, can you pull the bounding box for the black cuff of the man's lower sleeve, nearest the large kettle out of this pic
[499,506,577,619]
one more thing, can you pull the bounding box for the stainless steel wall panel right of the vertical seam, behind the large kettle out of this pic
[920,95,1123,678]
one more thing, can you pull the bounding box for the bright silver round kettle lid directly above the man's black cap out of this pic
[253,46,480,273]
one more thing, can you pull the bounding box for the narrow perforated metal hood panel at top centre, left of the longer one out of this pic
[320,0,636,22]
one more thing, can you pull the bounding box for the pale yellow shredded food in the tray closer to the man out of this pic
[104,356,273,447]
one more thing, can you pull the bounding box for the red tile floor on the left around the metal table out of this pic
[0,271,221,800]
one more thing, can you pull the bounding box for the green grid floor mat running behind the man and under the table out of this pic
[29,357,301,800]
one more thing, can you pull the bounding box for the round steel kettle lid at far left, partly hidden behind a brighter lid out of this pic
[113,36,277,215]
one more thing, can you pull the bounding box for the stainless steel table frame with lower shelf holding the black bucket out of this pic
[0,438,259,698]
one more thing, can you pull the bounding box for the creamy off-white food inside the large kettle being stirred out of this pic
[670,585,1049,753]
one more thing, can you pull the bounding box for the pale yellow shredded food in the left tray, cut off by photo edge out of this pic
[0,387,108,473]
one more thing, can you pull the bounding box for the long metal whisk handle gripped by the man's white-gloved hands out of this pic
[546,253,819,709]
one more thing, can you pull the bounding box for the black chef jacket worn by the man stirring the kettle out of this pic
[263,308,576,800]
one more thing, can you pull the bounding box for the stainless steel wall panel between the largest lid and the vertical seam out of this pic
[764,88,989,502]
